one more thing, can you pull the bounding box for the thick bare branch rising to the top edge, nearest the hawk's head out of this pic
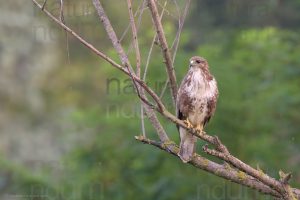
[148,0,177,105]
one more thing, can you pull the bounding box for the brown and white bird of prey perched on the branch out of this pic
[176,56,219,163]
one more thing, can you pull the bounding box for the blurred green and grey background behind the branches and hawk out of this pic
[0,0,300,200]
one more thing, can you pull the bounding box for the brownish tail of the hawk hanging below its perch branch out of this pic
[178,128,197,163]
